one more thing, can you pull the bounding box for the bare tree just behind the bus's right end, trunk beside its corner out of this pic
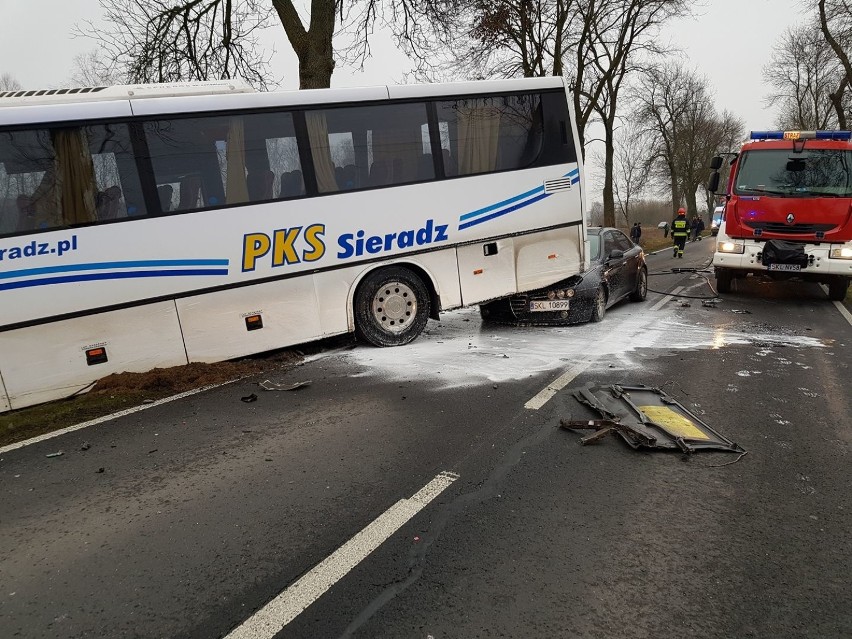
[410,0,689,224]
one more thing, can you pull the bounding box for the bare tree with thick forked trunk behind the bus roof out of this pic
[78,0,456,89]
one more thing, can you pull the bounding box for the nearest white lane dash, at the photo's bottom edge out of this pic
[225,471,459,639]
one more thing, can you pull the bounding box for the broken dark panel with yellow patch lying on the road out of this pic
[560,384,745,453]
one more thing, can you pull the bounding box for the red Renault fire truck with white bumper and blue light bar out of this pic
[707,131,852,300]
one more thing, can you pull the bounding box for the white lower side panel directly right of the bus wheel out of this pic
[456,238,517,306]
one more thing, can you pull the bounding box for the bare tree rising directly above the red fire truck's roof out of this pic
[763,23,844,130]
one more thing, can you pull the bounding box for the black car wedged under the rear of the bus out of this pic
[479,228,648,325]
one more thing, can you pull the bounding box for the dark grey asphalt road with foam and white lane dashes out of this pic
[0,241,852,639]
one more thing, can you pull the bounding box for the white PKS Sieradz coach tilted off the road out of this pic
[0,77,587,411]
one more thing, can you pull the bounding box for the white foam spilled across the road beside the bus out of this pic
[341,305,824,388]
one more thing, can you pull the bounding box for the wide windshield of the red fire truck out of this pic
[734,149,852,197]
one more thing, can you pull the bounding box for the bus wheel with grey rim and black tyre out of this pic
[355,266,430,346]
